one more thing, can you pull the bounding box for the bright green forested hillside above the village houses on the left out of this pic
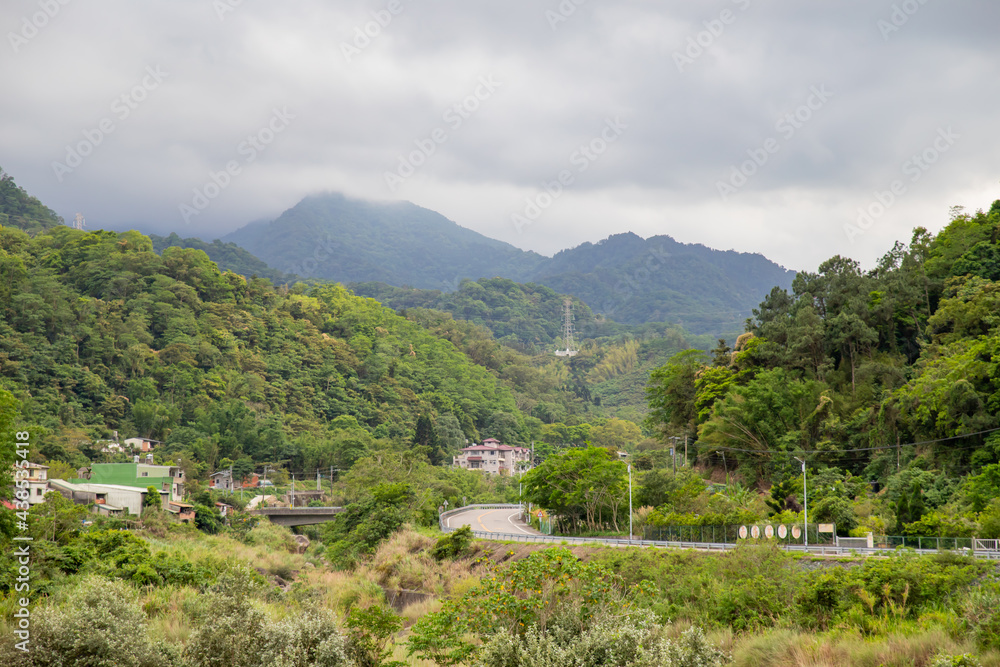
[0,222,586,478]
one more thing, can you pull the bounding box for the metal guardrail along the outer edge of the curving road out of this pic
[438,504,1000,560]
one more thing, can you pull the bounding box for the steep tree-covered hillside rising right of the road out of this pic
[649,201,1000,536]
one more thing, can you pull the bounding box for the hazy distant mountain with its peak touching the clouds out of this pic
[222,194,544,288]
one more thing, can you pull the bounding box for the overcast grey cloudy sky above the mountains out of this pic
[0,0,1000,271]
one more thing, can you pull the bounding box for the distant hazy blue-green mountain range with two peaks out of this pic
[223,194,795,334]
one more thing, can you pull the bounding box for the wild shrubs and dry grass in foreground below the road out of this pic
[0,488,1000,667]
